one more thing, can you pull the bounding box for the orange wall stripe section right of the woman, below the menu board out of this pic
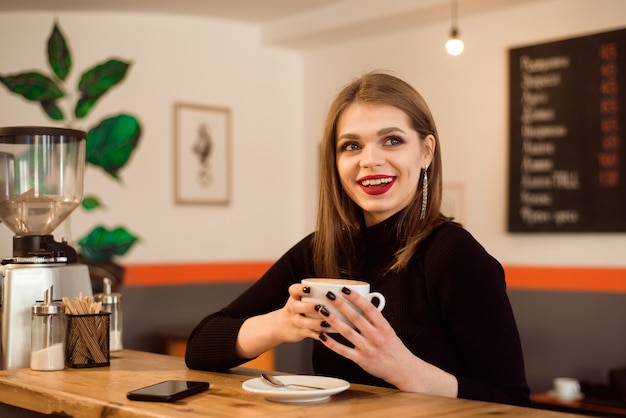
[504,266,626,293]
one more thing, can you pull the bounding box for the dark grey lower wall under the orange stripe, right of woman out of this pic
[509,290,626,392]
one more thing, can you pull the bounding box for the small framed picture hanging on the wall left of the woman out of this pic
[174,103,231,205]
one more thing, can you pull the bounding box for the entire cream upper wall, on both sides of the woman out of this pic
[0,0,626,266]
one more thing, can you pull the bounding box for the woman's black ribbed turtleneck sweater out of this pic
[185,215,530,406]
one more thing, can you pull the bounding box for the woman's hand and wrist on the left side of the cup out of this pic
[236,283,324,358]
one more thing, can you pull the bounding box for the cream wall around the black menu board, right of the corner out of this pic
[303,0,626,266]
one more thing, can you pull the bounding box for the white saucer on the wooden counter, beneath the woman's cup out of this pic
[241,375,350,402]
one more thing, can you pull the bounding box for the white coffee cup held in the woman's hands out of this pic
[302,278,385,332]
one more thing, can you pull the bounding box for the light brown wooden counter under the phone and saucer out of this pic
[0,350,572,418]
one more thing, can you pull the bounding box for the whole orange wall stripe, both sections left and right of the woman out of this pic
[124,261,626,293]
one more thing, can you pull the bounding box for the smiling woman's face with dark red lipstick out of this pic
[336,102,435,226]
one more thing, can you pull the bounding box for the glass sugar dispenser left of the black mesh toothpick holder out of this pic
[30,286,66,370]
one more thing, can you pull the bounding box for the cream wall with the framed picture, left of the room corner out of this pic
[0,13,306,262]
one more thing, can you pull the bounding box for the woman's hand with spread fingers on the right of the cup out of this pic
[317,288,458,397]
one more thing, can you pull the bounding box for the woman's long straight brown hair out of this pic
[313,72,448,277]
